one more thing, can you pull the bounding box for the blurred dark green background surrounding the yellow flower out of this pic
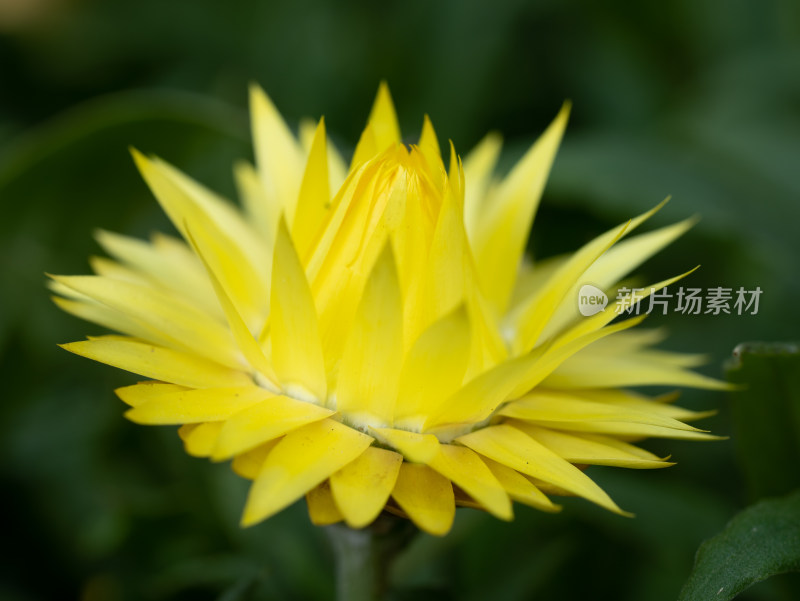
[0,0,800,601]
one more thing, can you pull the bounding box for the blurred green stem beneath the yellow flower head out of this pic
[326,514,416,601]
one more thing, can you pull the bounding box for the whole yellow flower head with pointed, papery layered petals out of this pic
[52,85,720,535]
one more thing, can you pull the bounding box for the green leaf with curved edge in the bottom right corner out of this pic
[678,490,800,601]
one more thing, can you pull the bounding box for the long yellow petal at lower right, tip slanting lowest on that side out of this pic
[456,424,624,514]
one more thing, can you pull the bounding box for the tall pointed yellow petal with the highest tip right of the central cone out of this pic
[474,103,570,314]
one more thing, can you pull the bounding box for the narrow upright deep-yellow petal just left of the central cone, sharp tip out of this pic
[292,118,331,259]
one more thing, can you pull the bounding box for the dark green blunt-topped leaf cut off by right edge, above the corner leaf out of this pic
[727,343,800,500]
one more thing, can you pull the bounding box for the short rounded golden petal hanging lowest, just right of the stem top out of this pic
[392,463,456,536]
